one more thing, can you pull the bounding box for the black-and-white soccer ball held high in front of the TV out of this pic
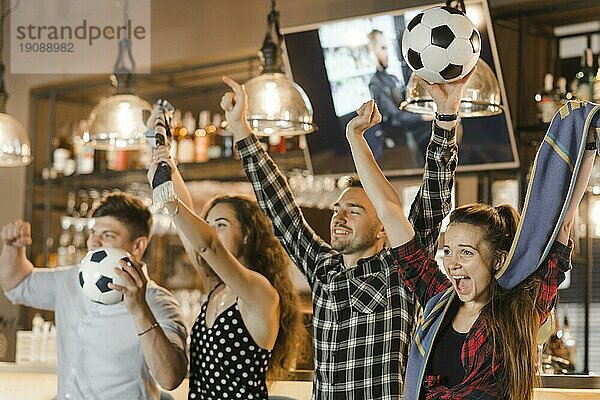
[402,7,481,83]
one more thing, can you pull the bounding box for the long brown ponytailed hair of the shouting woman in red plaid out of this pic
[450,203,540,400]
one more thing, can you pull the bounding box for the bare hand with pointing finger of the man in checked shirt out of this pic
[221,76,252,140]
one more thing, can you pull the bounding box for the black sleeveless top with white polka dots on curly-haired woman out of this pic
[188,288,271,400]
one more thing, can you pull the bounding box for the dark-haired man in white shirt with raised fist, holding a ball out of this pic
[0,193,187,400]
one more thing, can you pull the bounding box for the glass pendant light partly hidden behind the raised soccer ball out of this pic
[400,0,502,118]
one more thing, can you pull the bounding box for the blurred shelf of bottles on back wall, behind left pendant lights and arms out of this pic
[41,110,306,187]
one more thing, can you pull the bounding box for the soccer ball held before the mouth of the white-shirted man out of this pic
[79,247,131,304]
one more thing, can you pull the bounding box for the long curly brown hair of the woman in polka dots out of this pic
[202,195,307,381]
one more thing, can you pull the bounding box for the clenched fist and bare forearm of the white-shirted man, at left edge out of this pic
[0,220,33,290]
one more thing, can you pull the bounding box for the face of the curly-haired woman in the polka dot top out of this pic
[206,203,244,257]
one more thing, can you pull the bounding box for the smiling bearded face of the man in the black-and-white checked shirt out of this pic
[330,187,385,257]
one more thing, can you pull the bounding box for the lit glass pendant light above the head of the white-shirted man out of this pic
[89,0,152,150]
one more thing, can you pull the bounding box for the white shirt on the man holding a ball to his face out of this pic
[5,266,187,400]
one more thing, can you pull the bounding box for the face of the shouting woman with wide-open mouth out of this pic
[444,223,493,306]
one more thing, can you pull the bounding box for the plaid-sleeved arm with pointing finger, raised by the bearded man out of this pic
[221,77,336,284]
